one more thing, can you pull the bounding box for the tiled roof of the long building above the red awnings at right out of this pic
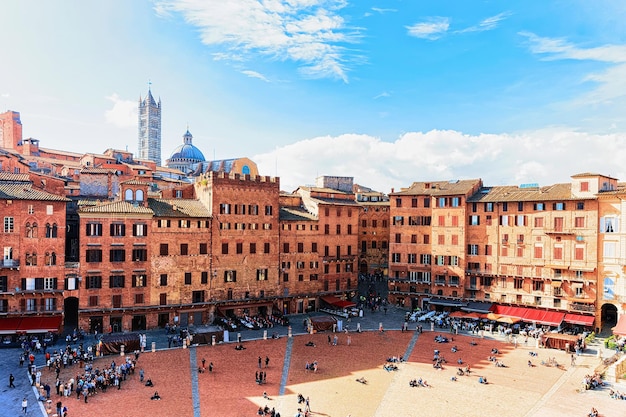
[467,183,595,203]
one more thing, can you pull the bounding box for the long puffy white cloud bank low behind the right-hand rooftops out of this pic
[252,129,626,192]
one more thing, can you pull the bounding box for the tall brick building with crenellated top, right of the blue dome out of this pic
[195,172,282,316]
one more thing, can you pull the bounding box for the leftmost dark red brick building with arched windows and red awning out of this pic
[0,172,68,333]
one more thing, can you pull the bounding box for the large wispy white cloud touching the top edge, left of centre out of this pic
[155,0,359,81]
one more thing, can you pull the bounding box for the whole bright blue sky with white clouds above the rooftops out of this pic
[0,0,626,192]
